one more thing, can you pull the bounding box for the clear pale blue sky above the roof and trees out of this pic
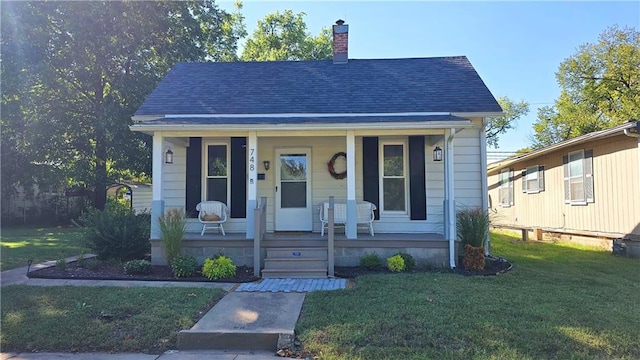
[218,0,640,162]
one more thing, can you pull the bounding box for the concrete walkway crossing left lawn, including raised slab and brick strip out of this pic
[0,257,346,360]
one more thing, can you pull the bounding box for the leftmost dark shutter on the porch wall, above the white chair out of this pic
[185,137,202,217]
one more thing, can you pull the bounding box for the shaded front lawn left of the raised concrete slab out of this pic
[0,285,224,354]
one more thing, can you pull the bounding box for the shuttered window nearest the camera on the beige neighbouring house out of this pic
[562,150,594,205]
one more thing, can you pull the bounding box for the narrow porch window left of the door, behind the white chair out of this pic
[203,144,229,204]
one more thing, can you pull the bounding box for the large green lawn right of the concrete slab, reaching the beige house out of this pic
[296,233,640,359]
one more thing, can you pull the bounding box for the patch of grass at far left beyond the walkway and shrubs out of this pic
[0,227,89,271]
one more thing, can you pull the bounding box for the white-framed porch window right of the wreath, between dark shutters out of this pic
[380,142,407,214]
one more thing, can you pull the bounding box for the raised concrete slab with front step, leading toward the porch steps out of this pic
[178,292,305,351]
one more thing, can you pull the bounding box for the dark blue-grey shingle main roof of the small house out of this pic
[135,56,502,115]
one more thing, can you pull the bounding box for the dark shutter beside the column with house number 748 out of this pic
[230,137,247,218]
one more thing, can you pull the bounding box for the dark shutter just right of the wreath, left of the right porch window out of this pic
[362,137,380,220]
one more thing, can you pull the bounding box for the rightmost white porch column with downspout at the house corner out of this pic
[444,129,457,269]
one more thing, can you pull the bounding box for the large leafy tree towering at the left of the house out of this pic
[1,1,244,209]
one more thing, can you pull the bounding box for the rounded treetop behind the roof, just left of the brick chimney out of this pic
[241,10,333,61]
